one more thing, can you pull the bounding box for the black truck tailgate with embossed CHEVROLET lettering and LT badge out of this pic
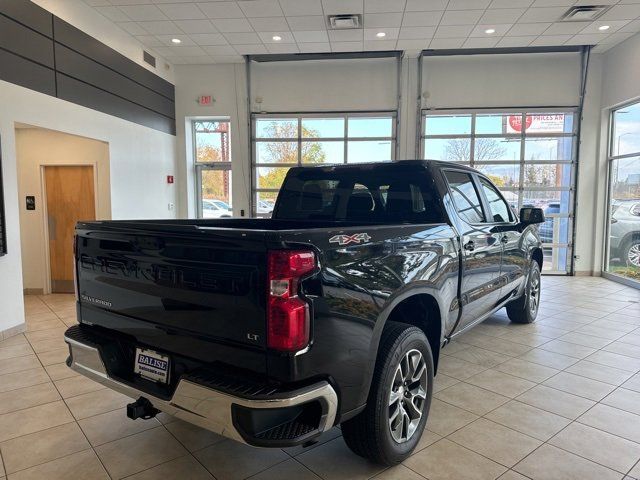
[76,222,267,353]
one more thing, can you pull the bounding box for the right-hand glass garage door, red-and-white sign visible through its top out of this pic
[421,111,576,274]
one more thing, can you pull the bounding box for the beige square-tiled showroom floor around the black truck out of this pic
[0,277,640,480]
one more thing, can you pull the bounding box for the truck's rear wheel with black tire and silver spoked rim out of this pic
[342,322,433,466]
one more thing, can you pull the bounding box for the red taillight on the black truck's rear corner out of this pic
[267,250,316,352]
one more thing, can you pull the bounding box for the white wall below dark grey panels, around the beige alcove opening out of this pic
[0,81,177,331]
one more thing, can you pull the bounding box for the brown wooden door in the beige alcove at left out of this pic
[44,166,96,293]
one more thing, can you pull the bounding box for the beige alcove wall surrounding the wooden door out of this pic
[16,128,111,293]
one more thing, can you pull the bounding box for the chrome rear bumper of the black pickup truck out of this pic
[65,335,338,446]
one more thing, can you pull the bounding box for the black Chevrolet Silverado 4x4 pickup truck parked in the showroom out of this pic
[65,160,544,465]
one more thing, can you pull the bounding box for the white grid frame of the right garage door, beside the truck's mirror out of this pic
[418,107,579,275]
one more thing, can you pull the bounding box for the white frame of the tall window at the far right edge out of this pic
[601,99,640,288]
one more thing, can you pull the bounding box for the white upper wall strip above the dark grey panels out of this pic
[31,0,177,83]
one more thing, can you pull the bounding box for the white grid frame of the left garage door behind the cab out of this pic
[251,110,398,217]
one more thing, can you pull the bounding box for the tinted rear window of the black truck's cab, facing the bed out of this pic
[273,167,444,223]
